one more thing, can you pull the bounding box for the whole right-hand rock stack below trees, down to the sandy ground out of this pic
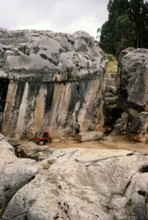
[116,48,148,142]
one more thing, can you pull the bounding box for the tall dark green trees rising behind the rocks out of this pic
[100,0,148,56]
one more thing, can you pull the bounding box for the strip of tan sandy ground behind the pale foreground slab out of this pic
[49,135,148,154]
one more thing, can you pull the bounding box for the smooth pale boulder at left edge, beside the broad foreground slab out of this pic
[0,140,37,217]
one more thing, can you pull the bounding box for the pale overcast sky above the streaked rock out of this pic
[0,0,109,37]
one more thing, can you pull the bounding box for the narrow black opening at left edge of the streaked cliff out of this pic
[0,78,9,129]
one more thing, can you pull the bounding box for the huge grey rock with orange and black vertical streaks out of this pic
[0,29,107,137]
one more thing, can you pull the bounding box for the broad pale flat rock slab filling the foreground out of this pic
[0,145,148,220]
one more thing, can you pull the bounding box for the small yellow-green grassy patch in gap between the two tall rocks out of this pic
[106,54,118,76]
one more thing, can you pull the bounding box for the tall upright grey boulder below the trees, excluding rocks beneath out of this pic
[116,48,148,118]
